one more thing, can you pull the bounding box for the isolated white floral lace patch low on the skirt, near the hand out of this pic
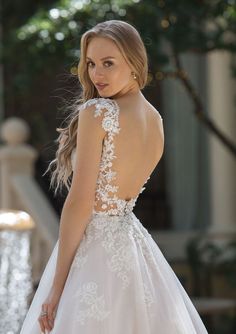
[74,282,110,325]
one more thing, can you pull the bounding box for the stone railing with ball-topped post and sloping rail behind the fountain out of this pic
[0,117,59,283]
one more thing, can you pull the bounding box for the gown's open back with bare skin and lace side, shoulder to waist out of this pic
[72,98,164,215]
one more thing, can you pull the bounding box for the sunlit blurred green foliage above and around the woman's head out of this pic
[2,0,236,81]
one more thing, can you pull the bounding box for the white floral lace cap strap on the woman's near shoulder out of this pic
[81,98,120,135]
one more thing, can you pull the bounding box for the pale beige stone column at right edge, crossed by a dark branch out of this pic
[207,51,236,236]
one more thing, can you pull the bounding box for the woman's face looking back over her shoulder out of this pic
[86,37,138,97]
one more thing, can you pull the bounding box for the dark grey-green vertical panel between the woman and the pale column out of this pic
[162,52,209,231]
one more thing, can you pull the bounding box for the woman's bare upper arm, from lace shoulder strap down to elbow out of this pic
[67,105,106,208]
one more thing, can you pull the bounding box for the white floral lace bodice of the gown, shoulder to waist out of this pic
[71,98,150,216]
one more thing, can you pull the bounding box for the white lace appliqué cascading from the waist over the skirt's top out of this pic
[72,214,156,289]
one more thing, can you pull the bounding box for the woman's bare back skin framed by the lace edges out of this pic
[110,96,164,204]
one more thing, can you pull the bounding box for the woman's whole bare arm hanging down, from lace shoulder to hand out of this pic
[39,106,106,332]
